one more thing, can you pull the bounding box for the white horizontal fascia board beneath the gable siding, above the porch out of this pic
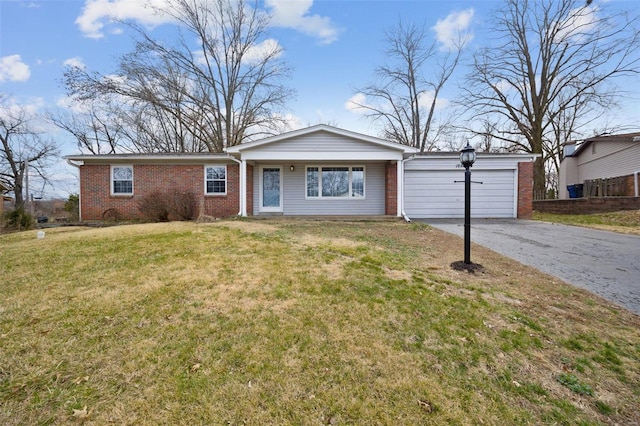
[242,151,402,161]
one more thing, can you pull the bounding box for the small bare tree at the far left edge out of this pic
[0,93,58,208]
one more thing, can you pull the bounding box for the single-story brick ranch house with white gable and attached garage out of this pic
[66,125,535,220]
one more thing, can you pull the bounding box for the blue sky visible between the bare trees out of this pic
[0,0,640,196]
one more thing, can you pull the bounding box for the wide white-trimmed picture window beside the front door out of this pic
[306,166,365,198]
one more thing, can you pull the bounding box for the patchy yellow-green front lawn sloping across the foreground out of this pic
[0,220,640,425]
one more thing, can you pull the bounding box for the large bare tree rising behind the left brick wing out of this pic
[65,0,291,152]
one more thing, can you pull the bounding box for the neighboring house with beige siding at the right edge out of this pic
[558,132,640,199]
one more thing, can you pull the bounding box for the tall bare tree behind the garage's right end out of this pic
[464,0,640,192]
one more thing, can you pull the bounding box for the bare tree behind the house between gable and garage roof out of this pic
[351,22,466,152]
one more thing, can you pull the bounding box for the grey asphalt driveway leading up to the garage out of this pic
[422,219,640,315]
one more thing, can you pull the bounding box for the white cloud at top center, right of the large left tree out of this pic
[265,0,340,44]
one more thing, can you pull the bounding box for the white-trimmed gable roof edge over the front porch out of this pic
[226,124,418,154]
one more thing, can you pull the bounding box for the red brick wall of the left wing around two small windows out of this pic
[80,163,240,220]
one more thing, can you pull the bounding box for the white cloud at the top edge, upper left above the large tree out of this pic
[76,0,172,38]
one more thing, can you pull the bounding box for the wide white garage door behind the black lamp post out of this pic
[404,169,516,218]
